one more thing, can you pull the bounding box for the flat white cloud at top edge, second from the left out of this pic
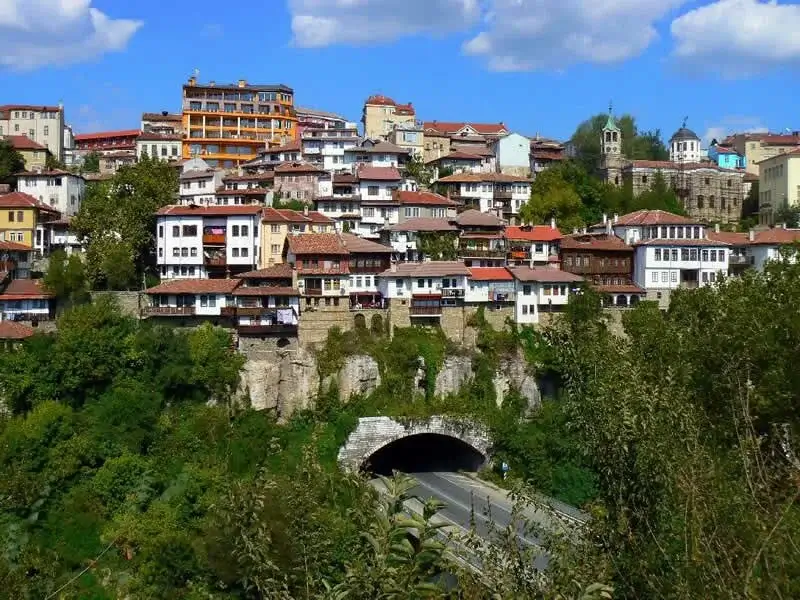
[289,0,481,48]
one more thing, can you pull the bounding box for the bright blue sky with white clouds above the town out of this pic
[0,0,800,140]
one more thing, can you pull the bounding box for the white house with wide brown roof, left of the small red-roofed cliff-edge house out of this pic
[378,261,470,323]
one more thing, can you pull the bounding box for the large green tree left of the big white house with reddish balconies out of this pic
[71,158,178,289]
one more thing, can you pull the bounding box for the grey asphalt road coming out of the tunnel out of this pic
[372,471,580,569]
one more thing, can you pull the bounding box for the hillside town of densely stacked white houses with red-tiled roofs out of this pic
[0,76,800,343]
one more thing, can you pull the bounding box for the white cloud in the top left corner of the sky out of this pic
[0,0,142,70]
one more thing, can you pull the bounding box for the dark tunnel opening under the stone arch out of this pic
[361,433,486,476]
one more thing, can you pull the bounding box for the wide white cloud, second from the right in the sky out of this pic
[464,0,686,71]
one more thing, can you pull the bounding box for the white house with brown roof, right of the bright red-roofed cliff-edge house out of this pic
[509,267,583,325]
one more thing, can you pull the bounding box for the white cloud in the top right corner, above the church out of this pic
[671,0,800,78]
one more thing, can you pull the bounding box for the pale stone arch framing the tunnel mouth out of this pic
[338,416,491,472]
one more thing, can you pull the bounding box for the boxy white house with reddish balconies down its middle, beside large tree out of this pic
[156,205,261,279]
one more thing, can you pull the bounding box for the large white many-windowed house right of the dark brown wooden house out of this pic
[591,210,730,306]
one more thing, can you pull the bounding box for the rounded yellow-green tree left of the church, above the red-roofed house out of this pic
[519,169,584,230]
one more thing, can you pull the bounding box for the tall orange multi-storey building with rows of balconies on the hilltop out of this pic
[183,77,297,168]
